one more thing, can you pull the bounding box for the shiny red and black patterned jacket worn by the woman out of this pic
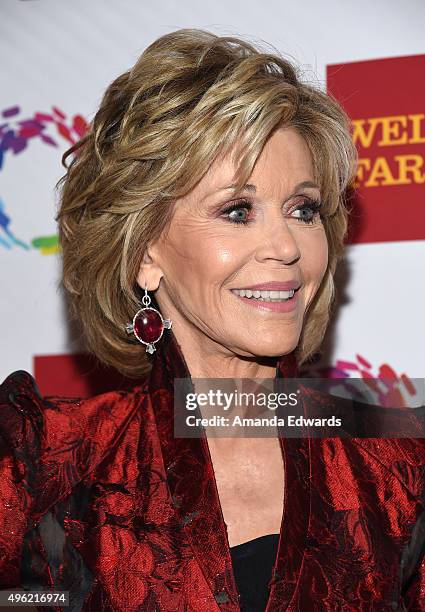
[0,333,425,612]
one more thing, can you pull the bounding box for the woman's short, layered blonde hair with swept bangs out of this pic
[57,29,356,378]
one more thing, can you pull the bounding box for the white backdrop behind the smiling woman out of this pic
[0,0,425,390]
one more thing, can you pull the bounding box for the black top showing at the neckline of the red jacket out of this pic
[230,533,279,612]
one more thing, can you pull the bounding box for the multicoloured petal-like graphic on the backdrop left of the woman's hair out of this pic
[0,106,88,255]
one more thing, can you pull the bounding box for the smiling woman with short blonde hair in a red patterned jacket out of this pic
[0,30,425,612]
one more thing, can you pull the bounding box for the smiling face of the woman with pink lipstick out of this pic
[138,128,328,357]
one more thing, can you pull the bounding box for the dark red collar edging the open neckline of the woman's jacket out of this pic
[149,330,310,612]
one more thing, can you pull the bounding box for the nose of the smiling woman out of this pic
[255,217,301,265]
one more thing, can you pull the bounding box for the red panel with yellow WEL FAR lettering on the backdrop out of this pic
[327,55,425,243]
